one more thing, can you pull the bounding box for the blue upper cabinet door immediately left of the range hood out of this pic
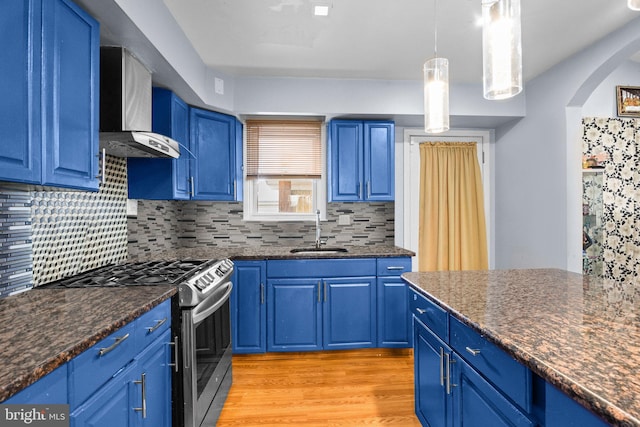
[42,0,100,190]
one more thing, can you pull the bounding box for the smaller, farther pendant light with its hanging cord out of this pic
[423,0,449,133]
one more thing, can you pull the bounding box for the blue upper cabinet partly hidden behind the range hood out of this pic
[127,88,194,200]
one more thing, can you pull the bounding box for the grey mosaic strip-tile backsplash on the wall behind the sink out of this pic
[129,200,395,259]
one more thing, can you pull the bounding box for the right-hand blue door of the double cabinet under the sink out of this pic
[322,277,376,350]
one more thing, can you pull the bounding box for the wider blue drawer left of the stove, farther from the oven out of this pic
[69,322,136,408]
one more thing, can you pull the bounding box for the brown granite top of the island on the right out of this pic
[402,269,640,426]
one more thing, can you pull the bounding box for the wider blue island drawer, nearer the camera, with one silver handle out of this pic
[449,316,531,412]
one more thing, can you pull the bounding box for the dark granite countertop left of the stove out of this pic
[0,286,176,402]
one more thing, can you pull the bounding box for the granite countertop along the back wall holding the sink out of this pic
[131,245,415,261]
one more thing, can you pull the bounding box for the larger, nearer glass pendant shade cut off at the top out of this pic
[482,0,522,100]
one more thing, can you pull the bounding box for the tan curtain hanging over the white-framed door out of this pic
[418,142,488,271]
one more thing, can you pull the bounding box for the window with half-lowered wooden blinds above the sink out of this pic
[244,120,326,221]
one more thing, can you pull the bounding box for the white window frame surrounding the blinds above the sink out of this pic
[242,122,327,222]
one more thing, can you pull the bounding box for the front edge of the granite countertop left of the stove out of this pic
[0,287,178,403]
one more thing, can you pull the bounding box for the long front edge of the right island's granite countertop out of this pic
[402,276,640,426]
